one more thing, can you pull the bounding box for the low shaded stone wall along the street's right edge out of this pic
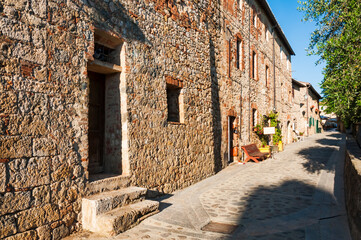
[344,136,361,239]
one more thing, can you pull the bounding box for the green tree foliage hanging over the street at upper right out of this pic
[299,0,361,122]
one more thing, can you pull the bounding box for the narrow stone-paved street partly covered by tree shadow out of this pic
[68,132,350,240]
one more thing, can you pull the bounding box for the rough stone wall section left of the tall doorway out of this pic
[0,0,91,239]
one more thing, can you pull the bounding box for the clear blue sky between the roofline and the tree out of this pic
[267,0,325,96]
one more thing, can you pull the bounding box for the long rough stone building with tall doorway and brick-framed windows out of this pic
[0,0,292,239]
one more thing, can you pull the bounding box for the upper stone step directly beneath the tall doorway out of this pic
[82,187,147,219]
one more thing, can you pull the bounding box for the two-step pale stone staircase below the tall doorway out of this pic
[82,187,159,236]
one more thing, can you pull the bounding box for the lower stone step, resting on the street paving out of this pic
[83,200,159,236]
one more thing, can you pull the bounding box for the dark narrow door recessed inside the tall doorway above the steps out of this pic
[88,72,105,174]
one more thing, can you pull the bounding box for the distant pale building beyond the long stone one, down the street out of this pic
[292,79,322,139]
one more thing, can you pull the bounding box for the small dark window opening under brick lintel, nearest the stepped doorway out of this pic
[167,84,181,122]
